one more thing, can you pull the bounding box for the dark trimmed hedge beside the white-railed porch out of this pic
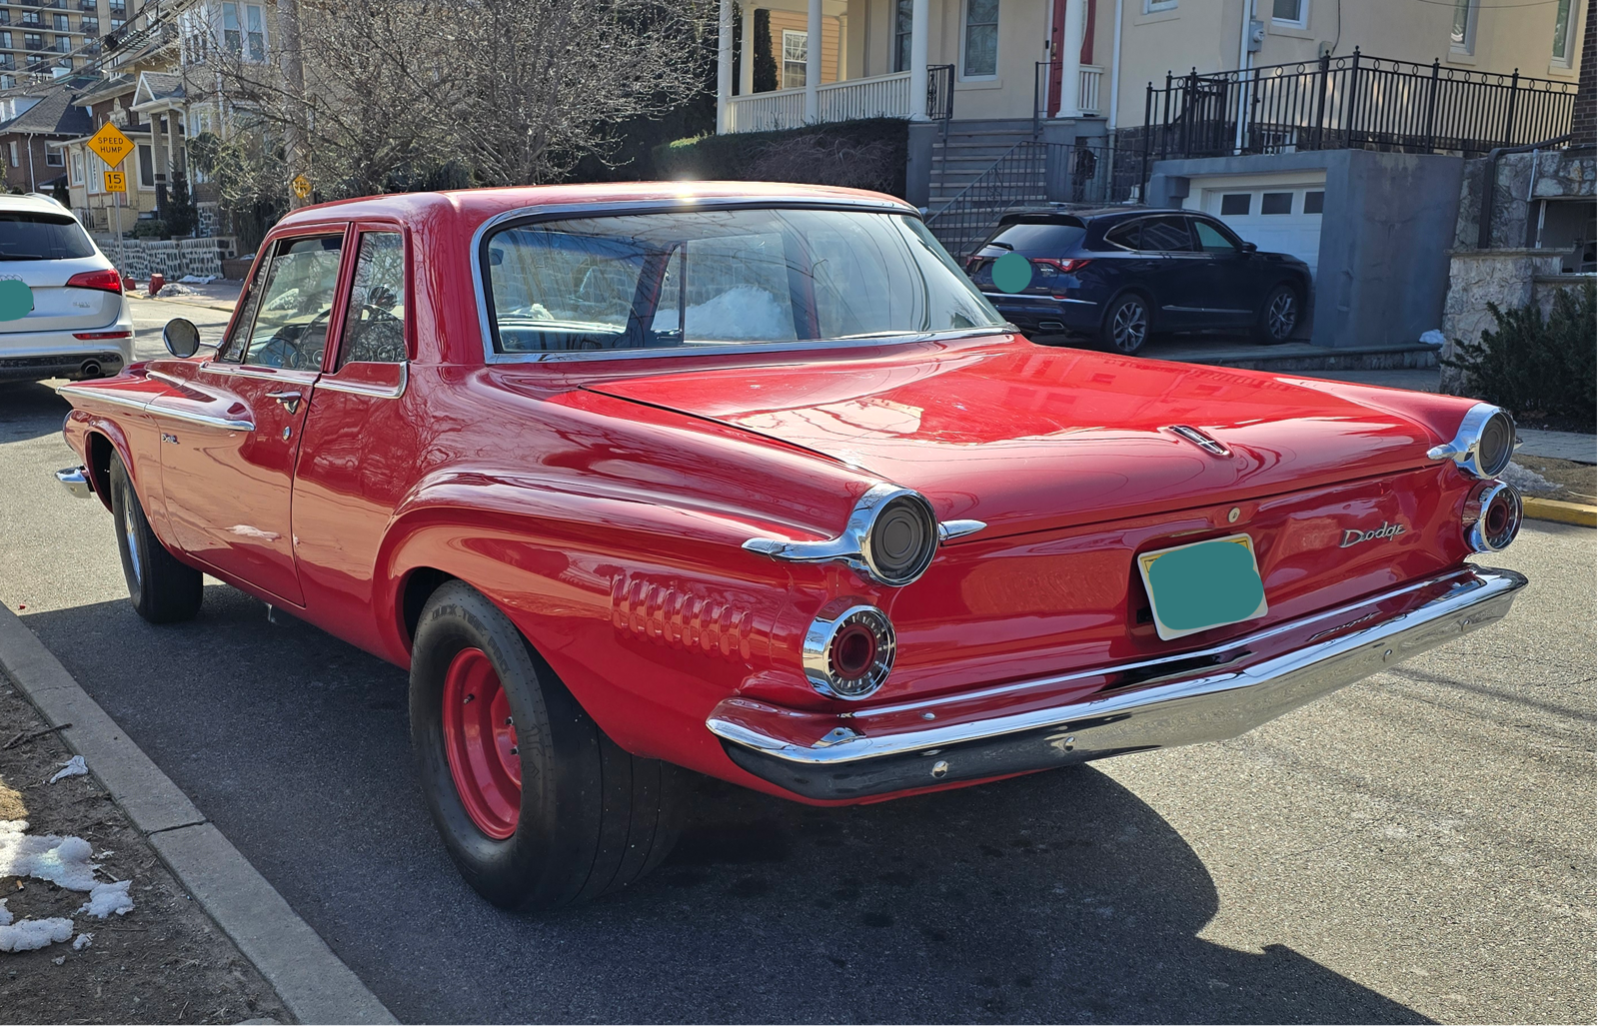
[651,118,907,197]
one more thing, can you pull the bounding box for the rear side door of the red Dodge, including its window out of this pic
[293,222,429,647]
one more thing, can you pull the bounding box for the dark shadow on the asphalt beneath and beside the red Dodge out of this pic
[24,586,1429,1023]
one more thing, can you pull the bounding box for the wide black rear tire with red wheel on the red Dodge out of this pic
[411,581,685,911]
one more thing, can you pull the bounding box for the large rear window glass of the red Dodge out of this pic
[486,210,1005,354]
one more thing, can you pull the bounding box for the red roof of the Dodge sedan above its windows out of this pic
[278,182,917,235]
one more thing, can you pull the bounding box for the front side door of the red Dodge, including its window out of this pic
[150,224,347,605]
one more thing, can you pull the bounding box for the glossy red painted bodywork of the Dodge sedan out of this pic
[66,182,1472,803]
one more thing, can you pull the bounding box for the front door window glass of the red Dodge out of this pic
[229,235,344,370]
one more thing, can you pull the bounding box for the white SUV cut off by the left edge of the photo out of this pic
[0,195,133,381]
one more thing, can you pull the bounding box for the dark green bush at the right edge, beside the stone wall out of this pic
[1445,282,1595,426]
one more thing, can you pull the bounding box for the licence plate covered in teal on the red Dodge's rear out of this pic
[1139,535,1267,642]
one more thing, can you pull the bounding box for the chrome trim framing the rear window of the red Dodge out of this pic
[470,197,1016,367]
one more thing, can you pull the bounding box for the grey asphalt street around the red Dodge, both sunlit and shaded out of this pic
[0,303,1595,1023]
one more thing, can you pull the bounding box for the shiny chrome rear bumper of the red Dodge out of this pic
[706,565,1528,800]
